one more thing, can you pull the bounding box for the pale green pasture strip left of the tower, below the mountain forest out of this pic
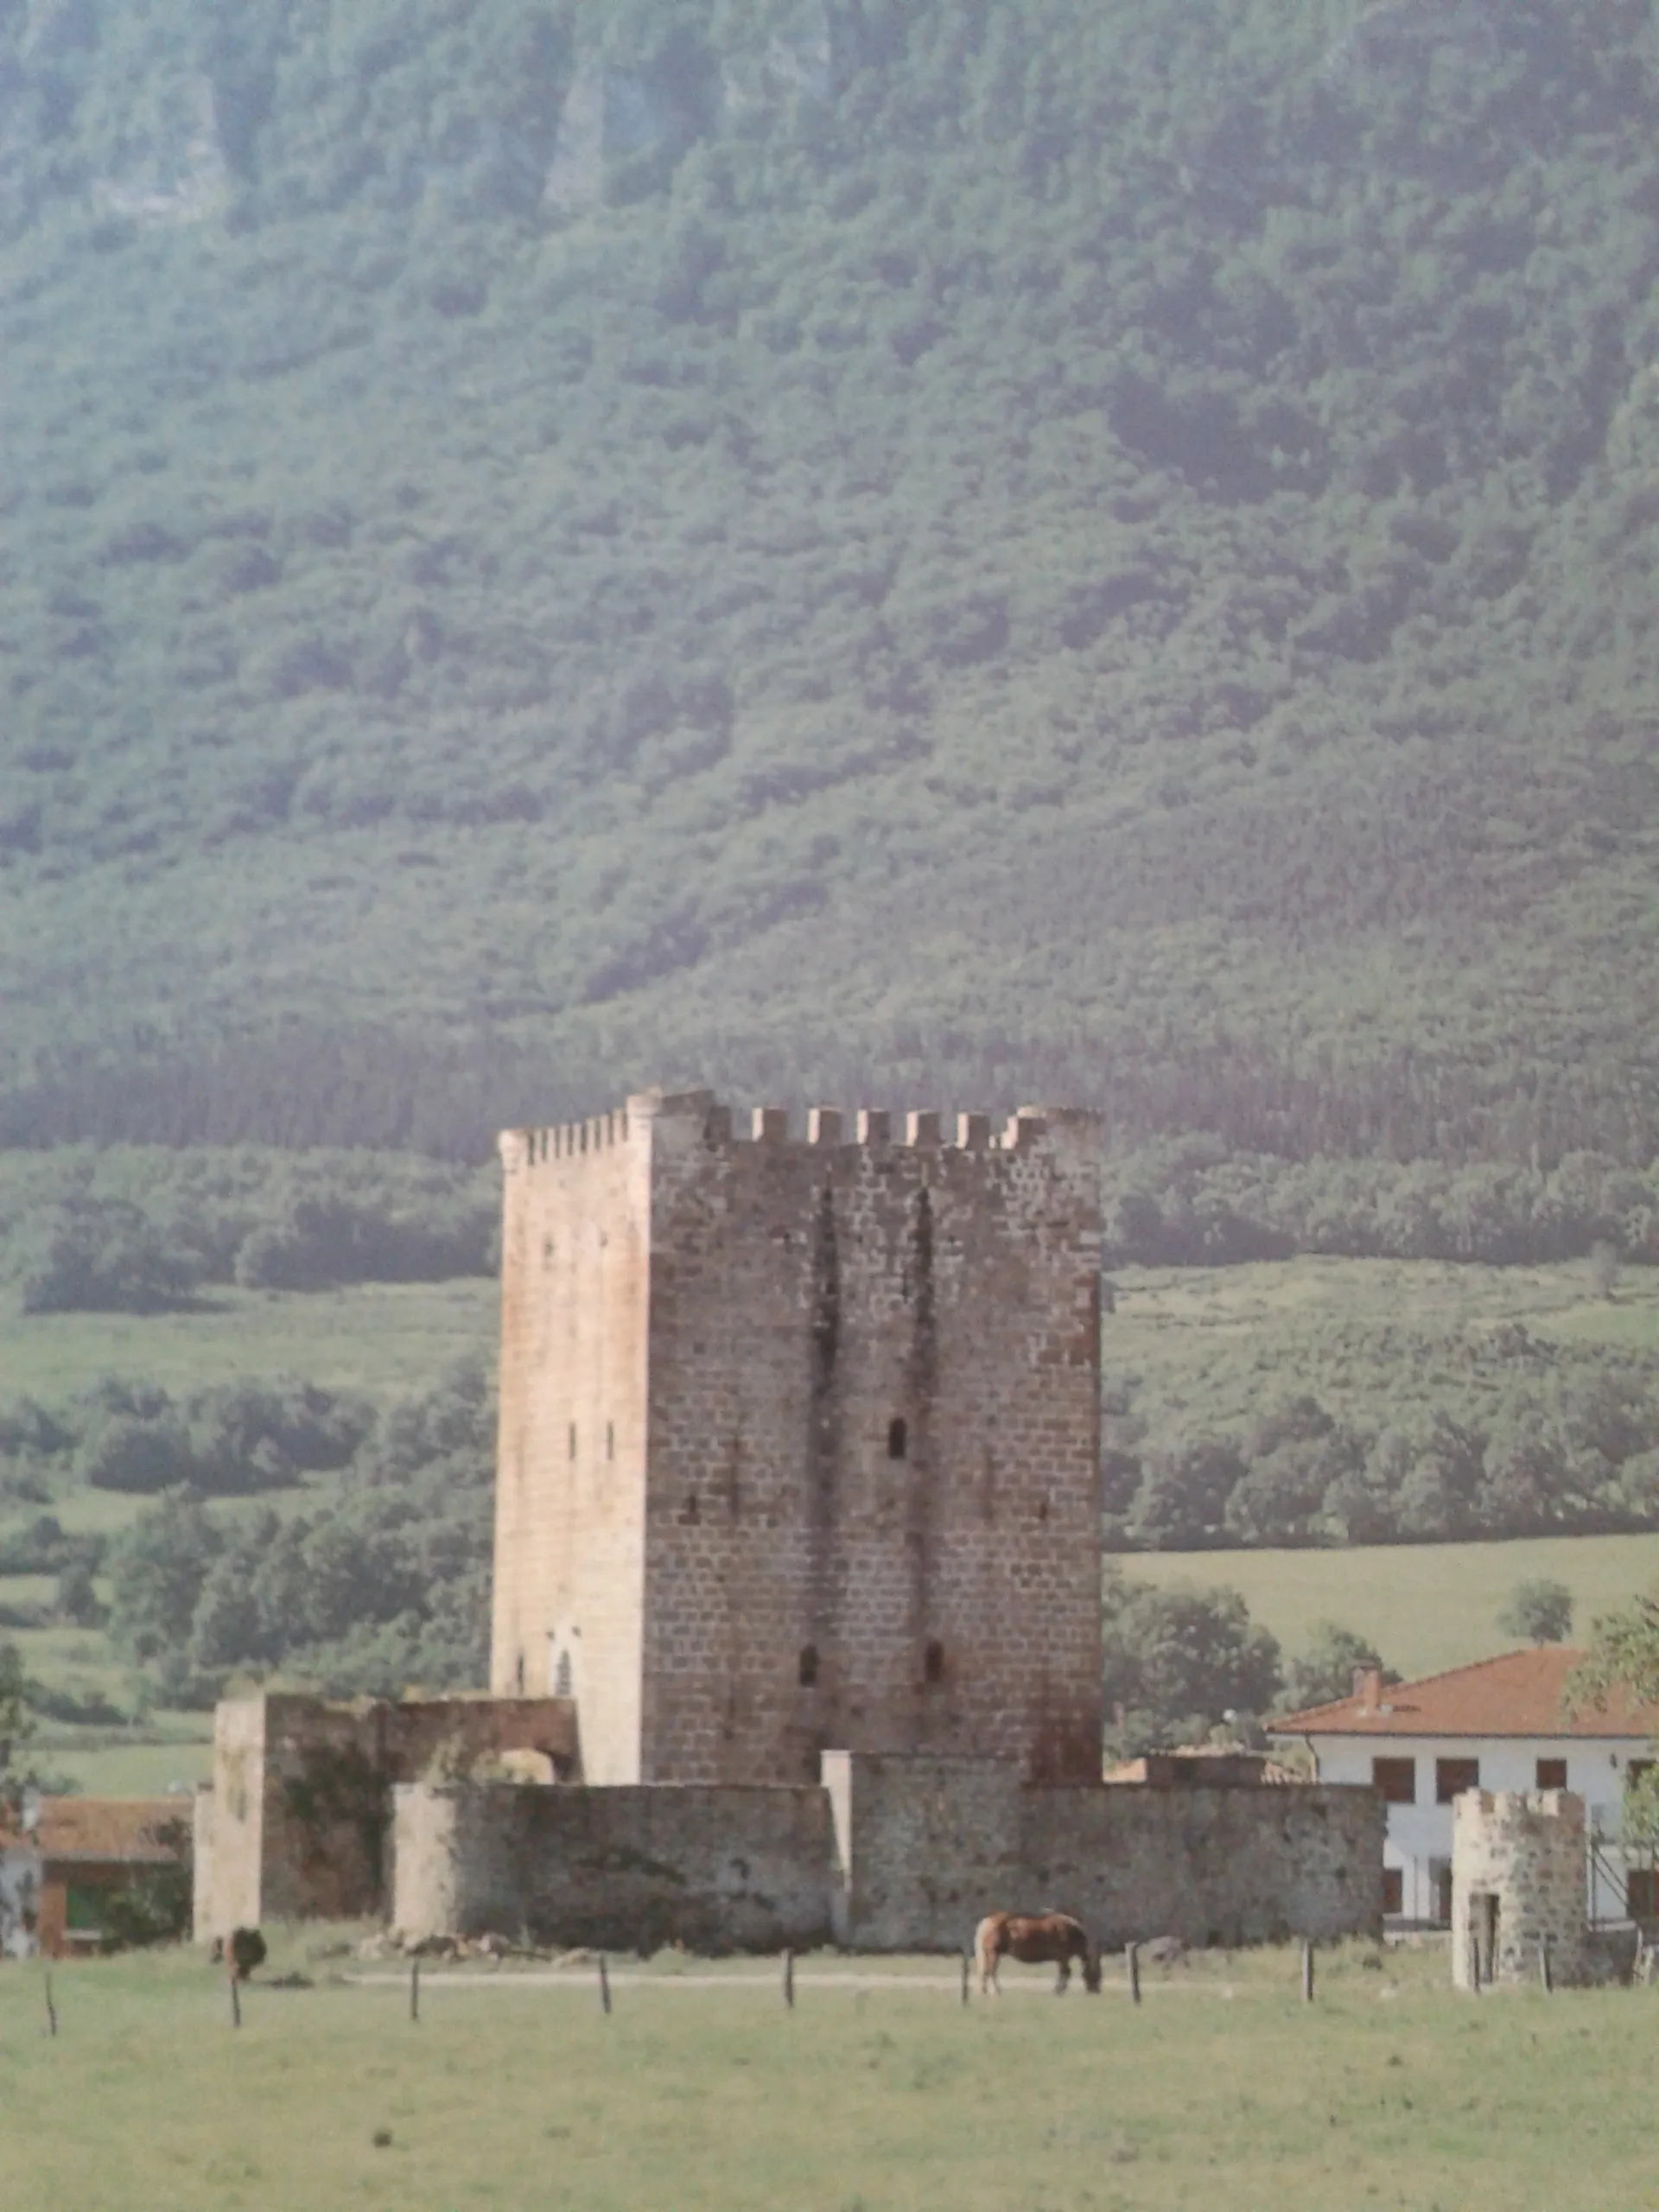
[0,1276,500,1402]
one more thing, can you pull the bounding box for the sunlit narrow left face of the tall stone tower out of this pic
[491,1102,651,1783]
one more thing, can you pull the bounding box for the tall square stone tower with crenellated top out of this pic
[491,1090,1102,1783]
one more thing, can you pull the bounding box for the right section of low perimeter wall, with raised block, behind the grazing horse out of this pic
[825,1754,1385,1951]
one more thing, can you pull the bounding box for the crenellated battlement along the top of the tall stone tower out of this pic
[498,1090,1099,1170]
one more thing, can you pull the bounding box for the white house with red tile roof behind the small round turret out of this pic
[1269,1643,1659,1924]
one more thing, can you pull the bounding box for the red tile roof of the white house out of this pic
[1269,1643,1659,1741]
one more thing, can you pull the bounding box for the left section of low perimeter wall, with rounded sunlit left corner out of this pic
[391,1783,832,1951]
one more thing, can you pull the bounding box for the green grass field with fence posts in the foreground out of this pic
[0,1947,1659,2212]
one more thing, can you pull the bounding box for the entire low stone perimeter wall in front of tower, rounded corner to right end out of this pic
[391,1752,1385,1951]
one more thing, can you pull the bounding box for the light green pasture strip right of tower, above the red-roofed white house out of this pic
[1119,1533,1659,1676]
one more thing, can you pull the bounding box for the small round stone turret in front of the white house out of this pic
[1451,1789,1606,1988]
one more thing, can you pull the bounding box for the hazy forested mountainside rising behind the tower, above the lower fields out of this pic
[0,0,1659,1173]
